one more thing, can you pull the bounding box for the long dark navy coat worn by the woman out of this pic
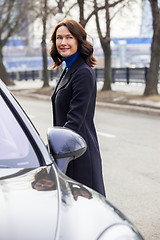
[52,57,105,195]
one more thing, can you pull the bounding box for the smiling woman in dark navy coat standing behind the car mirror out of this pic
[50,20,105,196]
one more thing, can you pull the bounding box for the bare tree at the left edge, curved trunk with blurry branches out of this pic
[0,0,29,85]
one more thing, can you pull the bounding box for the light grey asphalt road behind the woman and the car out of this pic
[17,97,160,240]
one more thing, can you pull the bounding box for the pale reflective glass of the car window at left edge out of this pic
[0,96,39,168]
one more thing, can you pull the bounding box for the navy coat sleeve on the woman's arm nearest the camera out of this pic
[65,68,96,132]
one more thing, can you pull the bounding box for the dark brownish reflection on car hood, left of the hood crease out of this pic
[32,168,56,191]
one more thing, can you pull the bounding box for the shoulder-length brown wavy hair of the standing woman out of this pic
[50,19,96,69]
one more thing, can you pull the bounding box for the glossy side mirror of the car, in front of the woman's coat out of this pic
[47,127,87,173]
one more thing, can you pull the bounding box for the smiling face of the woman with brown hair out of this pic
[56,26,78,57]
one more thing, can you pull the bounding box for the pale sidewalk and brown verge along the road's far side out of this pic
[9,80,160,115]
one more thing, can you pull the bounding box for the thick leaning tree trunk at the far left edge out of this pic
[0,48,14,86]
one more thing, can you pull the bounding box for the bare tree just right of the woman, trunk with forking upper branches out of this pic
[77,0,135,90]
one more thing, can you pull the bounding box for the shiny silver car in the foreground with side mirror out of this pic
[0,80,143,240]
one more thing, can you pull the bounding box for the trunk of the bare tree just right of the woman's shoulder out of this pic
[102,41,112,91]
